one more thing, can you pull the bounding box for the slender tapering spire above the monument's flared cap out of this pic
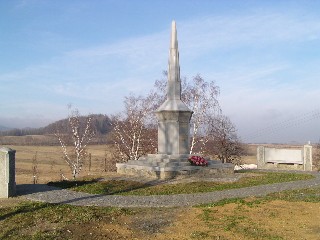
[167,21,181,100]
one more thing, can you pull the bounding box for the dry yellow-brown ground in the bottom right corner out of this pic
[157,200,320,239]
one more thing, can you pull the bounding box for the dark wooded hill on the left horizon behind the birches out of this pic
[0,114,111,136]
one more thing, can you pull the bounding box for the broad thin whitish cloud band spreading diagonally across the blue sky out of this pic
[0,6,320,142]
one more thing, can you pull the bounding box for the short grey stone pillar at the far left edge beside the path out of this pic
[0,147,16,198]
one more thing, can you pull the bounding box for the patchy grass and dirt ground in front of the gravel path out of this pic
[0,188,320,239]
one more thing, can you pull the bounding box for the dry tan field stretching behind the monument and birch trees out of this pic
[2,144,312,184]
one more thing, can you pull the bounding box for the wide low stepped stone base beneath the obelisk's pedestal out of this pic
[116,154,234,179]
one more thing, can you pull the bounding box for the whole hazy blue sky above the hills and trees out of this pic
[0,0,320,142]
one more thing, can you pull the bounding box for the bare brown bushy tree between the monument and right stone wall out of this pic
[206,115,244,165]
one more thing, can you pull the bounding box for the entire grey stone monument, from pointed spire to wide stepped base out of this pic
[116,21,234,179]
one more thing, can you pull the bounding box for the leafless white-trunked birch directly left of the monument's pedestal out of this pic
[112,94,156,162]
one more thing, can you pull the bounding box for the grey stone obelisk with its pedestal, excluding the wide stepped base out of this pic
[156,21,193,155]
